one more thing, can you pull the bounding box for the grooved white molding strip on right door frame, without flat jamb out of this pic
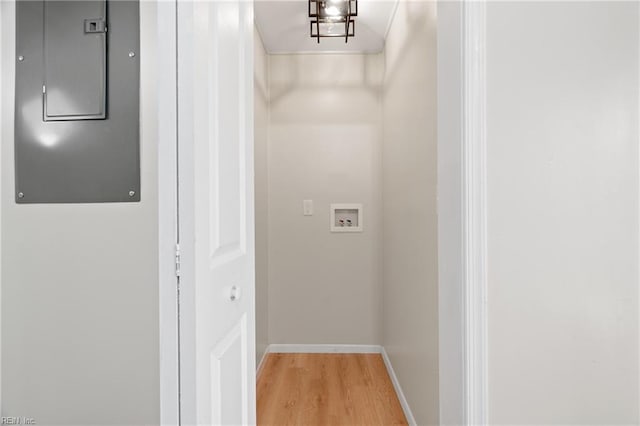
[463,0,489,425]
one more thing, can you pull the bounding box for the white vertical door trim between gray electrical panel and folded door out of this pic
[157,0,180,425]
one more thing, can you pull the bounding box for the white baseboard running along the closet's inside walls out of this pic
[257,344,417,426]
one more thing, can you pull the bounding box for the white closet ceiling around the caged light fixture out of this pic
[255,0,397,53]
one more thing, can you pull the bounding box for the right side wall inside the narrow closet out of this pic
[382,1,439,425]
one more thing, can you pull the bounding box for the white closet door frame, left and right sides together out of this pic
[158,0,488,425]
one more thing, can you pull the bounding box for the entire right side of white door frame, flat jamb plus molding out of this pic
[438,0,488,425]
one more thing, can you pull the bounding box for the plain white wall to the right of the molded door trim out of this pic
[487,2,640,424]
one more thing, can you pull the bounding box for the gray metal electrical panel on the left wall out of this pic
[15,0,140,203]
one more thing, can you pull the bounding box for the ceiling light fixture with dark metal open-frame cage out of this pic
[309,0,358,43]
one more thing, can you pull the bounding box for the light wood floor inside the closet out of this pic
[258,353,407,426]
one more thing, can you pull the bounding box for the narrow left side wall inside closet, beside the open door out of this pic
[253,29,269,365]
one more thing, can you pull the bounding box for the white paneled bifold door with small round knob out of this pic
[178,0,256,425]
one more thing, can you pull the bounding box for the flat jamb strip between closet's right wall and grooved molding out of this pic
[436,0,466,426]
